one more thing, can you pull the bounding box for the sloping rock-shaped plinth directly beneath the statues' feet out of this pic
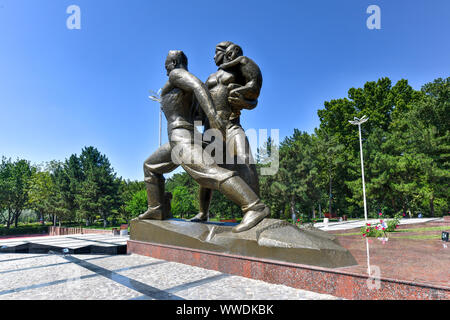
[130,219,356,268]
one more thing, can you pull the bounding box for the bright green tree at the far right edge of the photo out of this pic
[380,78,450,216]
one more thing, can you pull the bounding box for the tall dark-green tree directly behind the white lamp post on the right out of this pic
[318,78,423,218]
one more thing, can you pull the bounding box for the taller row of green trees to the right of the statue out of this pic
[261,78,450,217]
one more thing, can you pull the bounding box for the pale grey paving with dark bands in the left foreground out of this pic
[0,253,337,300]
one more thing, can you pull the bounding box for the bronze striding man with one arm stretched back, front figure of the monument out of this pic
[139,51,270,232]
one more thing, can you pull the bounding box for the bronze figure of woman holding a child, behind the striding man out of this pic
[192,41,262,221]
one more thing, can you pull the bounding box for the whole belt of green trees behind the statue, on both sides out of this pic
[0,78,450,227]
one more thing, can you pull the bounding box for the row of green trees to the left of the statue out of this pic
[0,147,144,228]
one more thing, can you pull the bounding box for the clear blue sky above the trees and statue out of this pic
[0,0,450,180]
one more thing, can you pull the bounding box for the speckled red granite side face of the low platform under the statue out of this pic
[127,240,450,300]
